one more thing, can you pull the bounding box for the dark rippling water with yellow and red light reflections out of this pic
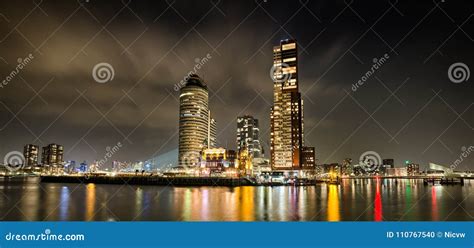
[0,178,474,221]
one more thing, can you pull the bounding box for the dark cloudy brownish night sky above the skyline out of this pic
[0,0,474,170]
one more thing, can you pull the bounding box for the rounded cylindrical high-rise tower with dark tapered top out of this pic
[178,74,217,166]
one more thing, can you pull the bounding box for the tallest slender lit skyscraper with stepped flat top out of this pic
[270,40,314,170]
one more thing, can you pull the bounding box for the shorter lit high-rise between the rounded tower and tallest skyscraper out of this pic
[237,115,263,158]
